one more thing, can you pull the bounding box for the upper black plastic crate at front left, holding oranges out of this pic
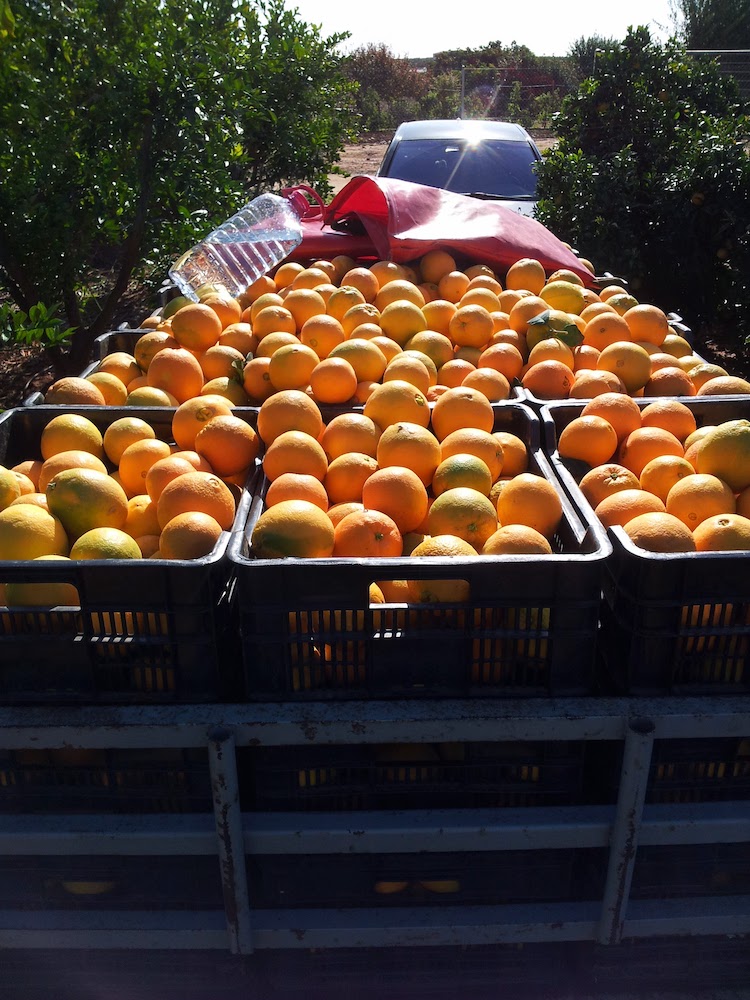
[0,406,253,704]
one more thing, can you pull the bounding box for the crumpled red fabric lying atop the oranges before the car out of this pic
[295,175,594,287]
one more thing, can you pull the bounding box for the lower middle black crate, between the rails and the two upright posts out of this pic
[247,740,585,812]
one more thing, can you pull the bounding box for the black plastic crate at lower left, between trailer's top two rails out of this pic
[0,748,212,814]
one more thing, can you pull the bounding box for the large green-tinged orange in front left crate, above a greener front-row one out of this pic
[46,466,129,542]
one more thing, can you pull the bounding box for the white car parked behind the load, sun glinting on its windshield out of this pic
[377,118,542,215]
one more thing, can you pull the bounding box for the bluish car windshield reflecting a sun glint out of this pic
[387,139,537,199]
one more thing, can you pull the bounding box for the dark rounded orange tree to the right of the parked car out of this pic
[538,28,750,354]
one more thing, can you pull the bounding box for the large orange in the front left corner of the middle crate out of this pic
[251,500,334,559]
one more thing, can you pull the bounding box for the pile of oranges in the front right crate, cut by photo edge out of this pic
[558,393,750,552]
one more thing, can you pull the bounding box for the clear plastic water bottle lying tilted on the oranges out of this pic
[169,188,310,301]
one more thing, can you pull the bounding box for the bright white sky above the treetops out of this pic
[286,0,674,57]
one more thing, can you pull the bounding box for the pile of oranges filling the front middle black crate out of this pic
[251,379,563,584]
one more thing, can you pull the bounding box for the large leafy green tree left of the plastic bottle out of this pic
[0,0,351,368]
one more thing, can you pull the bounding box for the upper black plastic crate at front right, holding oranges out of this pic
[541,396,750,695]
